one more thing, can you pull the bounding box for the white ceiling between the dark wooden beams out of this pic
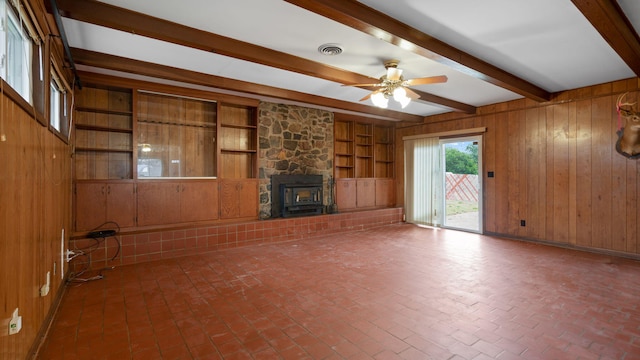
[60,0,640,121]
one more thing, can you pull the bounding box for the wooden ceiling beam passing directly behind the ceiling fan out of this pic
[57,0,476,114]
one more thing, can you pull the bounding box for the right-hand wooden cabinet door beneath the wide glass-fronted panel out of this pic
[180,181,218,222]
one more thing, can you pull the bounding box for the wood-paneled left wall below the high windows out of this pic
[0,96,71,359]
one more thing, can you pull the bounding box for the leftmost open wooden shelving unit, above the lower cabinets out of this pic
[74,85,133,179]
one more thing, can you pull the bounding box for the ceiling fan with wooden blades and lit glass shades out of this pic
[343,60,447,109]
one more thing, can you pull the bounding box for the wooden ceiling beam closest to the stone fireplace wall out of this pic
[71,48,424,122]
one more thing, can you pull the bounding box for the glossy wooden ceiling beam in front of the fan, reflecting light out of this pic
[285,0,551,101]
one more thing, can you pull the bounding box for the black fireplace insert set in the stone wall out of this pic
[271,175,324,217]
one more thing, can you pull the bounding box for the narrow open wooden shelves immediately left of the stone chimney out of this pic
[218,103,258,179]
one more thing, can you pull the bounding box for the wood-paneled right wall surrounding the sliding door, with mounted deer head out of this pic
[396,78,640,257]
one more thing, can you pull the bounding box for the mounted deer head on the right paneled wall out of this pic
[616,93,640,159]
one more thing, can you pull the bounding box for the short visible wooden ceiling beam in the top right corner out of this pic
[571,0,640,77]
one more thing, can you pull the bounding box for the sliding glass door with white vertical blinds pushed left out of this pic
[404,135,482,233]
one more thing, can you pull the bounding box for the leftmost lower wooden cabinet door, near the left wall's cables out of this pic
[75,182,107,231]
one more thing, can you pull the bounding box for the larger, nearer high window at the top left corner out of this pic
[0,0,33,103]
